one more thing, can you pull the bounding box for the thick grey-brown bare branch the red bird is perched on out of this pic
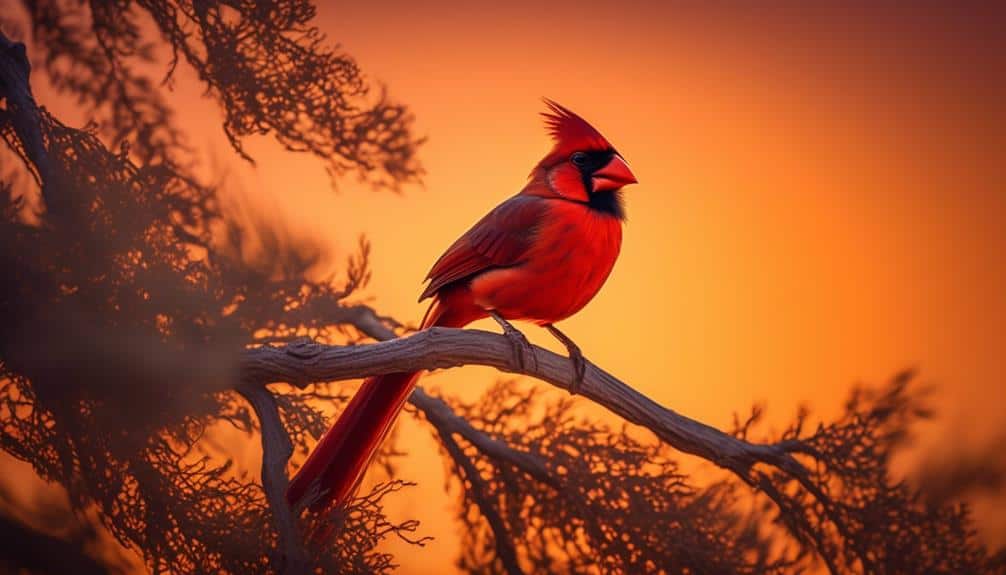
[241,328,807,485]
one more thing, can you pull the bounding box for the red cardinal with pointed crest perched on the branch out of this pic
[287,100,636,511]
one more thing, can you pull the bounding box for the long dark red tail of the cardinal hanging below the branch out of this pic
[287,301,476,511]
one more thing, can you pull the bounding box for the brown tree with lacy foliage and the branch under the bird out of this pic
[0,0,1006,573]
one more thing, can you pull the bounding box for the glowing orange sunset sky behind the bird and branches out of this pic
[15,0,1006,573]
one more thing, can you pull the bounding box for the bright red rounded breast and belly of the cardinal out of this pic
[471,200,622,324]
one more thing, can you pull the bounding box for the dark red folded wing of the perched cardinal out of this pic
[420,196,547,302]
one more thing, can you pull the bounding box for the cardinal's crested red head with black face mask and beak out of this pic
[531,99,637,217]
